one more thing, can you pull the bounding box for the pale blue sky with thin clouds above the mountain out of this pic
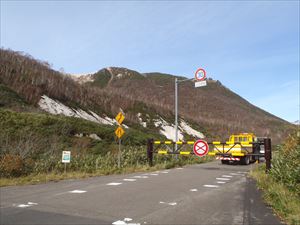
[0,0,300,122]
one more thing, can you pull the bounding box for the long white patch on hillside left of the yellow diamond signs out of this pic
[38,95,129,129]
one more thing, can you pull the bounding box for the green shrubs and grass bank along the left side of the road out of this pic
[0,109,210,186]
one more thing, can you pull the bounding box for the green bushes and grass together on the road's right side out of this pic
[251,133,300,225]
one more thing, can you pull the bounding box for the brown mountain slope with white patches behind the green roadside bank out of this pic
[0,49,295,143]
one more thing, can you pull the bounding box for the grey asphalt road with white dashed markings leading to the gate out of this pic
[0,162,281,225]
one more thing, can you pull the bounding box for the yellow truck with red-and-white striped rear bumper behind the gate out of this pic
[208,133,264,165]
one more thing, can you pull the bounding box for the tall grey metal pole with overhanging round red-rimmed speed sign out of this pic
[175,68,207,152]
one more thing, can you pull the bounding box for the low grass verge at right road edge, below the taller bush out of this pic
[250,163,300,225]
